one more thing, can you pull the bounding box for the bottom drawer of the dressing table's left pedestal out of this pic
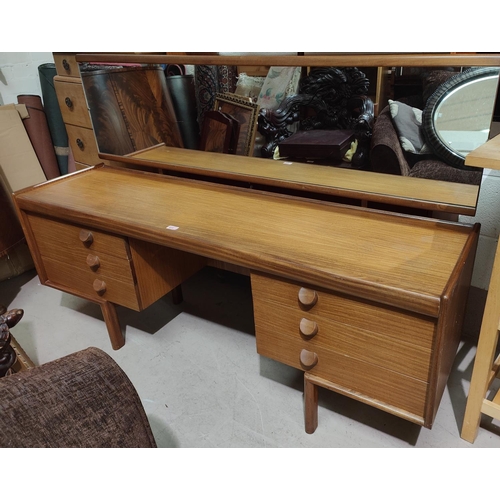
[42,256,140,311]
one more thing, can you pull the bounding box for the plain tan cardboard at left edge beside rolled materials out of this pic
[0,104,47,193]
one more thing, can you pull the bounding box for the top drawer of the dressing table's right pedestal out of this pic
[251,273,437,350]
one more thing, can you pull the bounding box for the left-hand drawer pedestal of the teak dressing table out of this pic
[25,209,206,311]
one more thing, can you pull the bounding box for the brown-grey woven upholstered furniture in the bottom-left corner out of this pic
[0,347,156,448]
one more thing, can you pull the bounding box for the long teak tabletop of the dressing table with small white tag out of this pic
[15,167,477,317]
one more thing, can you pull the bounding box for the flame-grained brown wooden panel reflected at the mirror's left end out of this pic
[81,67,183,155]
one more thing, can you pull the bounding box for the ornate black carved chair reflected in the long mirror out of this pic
[258,68,374,166]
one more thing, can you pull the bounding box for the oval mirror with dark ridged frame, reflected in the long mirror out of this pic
[422,68,499,168]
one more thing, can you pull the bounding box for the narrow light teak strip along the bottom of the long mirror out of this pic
[100,145,479,215]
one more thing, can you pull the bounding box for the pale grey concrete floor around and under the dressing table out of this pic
[0,268,500,448]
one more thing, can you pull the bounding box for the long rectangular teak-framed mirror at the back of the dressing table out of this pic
[57,54,500,214]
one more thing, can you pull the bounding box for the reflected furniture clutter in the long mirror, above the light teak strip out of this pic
[76,59,498,191]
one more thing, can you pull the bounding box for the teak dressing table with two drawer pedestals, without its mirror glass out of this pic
[14,54,500,432]
